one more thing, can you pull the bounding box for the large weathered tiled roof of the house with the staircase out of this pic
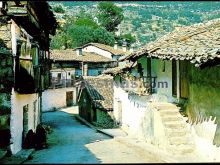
[120,19,220,66]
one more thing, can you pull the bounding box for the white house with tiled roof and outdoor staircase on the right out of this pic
[107,19,220,161]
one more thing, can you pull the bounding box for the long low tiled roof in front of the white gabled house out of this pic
[50,49,112,62]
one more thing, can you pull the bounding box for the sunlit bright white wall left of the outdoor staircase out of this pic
[113,81,153,138]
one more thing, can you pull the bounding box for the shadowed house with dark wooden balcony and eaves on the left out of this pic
[0,1,57,154]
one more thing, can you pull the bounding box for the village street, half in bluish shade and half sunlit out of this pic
[24,107,163,164]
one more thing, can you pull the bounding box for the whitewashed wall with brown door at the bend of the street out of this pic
[42,87,77,112]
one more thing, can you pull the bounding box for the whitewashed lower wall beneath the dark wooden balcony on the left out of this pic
[10,90,40,154]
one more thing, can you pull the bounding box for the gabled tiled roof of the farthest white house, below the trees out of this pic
[78,43,128,55]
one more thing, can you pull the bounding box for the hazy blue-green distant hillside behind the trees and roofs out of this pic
[50,1,220,46]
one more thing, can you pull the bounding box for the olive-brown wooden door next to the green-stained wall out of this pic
[179,61,189,98]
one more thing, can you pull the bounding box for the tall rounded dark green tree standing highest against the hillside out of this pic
[97,2,124,32]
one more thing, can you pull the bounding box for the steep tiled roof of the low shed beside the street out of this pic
[83,75,113,111]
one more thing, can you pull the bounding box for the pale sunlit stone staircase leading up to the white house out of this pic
[156,103,195,155]
